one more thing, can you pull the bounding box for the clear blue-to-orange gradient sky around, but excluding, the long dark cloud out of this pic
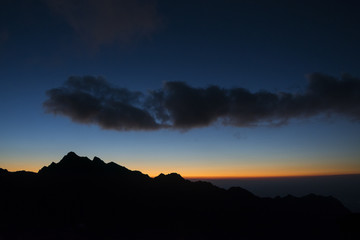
[0,0,360,177]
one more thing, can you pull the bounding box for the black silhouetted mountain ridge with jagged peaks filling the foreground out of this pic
[0,152,359,239]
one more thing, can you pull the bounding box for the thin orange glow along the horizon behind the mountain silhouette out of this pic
[0,159,360,179]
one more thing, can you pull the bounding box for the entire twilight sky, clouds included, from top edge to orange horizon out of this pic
[0,0,360,177]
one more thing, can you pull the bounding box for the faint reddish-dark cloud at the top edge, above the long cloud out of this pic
[43,0,159,48]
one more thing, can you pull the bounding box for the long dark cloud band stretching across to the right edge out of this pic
[44,73,360,131]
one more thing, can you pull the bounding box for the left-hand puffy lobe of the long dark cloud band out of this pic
[44,76,159,130]
